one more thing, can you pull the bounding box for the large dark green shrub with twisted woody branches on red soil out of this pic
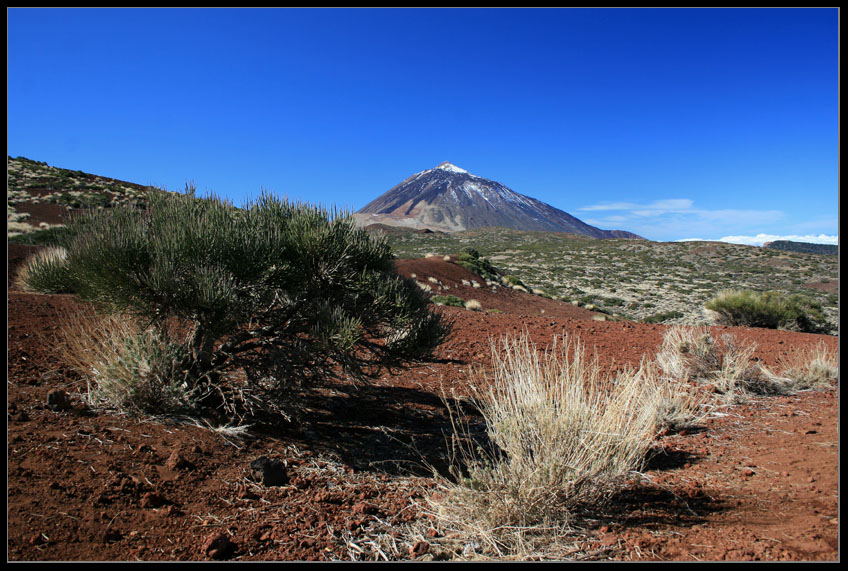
[50,188,450,419]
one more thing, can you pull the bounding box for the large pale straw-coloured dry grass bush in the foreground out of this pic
[432,337,659,551]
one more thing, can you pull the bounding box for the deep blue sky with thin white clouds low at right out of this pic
[7,8,839,244]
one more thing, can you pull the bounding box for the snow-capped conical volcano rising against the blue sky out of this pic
[355,162,640,238]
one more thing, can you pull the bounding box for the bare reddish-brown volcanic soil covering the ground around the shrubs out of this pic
[7,245,839,561]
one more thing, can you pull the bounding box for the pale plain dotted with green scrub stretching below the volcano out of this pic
[386,228,839,334]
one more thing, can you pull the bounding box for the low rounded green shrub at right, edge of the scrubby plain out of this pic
[704,290,827,333]
